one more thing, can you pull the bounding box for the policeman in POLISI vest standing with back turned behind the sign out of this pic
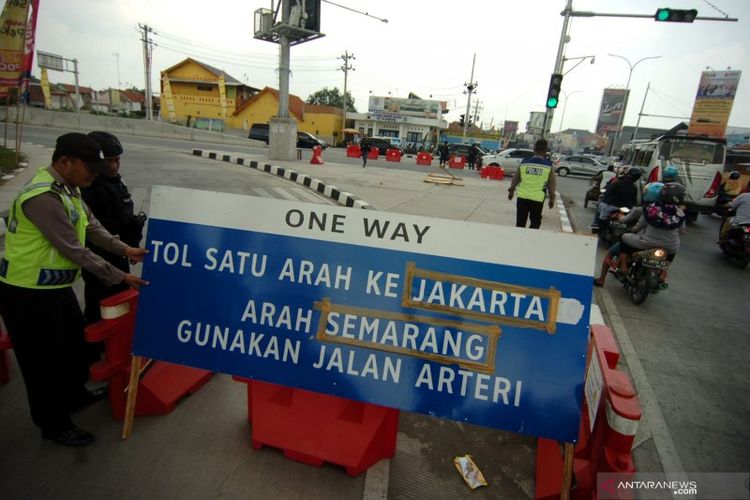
[508,139,556,229]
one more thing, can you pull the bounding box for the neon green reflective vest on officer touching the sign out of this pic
[0,167,89,289]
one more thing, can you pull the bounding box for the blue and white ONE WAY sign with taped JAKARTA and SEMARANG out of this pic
[133,186,596,442]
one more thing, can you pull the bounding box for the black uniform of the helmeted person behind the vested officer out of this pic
[81,175,146,325]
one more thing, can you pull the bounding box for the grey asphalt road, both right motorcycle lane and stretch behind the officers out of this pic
[9,127,750,472]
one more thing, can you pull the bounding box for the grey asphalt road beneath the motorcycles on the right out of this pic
[558,177,750,472]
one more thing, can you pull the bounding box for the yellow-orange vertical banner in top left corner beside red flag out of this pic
[0,1,27,87]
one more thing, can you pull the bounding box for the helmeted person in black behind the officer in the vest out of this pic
[81,132,146,330]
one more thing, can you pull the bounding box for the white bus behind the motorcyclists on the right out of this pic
[622,134,726,221]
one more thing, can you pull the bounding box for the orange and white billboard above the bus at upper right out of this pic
[688,71,742,137]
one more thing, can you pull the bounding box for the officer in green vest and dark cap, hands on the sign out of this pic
[0,132,148,446]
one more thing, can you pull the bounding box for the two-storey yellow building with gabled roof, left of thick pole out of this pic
[161,58,259,127]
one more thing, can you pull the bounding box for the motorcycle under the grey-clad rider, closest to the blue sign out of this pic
[610,248,669,306]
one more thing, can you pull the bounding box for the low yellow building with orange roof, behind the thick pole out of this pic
[232,87,342,144]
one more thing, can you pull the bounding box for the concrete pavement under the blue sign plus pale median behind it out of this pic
[0,144,572,500]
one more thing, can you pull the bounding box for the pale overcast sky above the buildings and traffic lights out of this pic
[27,0,750,132]
